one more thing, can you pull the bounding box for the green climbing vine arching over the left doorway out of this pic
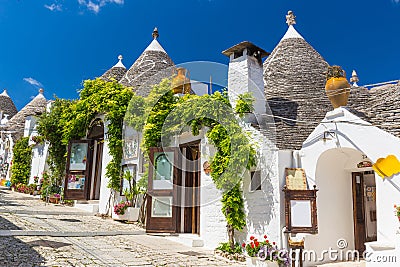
[39,79,133,191]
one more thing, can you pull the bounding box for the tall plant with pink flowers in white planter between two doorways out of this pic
[112,171,143,222]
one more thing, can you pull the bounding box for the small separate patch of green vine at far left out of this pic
[11,137,32,185]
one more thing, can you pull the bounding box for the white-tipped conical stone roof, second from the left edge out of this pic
[6,89,47,140]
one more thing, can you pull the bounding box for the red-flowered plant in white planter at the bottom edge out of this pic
[242,235,290,267]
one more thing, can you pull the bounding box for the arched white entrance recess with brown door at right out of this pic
[306,148,377,256]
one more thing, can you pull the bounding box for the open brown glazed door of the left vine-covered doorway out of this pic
[64,140,93,200]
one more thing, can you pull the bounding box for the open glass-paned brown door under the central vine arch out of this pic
[146,147,180,233]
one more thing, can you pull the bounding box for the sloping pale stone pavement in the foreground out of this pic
[0,187,245,267]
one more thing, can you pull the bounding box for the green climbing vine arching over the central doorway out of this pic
[126,79,256,247]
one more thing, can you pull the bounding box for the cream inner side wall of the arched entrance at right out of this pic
[305,149,361,265]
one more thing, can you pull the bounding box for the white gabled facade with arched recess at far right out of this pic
[300,107,400,266]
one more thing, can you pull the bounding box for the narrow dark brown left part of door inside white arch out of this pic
[352,172,366,255]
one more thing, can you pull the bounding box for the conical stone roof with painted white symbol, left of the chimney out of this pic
[120,28,174,96]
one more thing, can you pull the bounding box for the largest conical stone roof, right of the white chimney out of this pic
[264,14,332,149]
